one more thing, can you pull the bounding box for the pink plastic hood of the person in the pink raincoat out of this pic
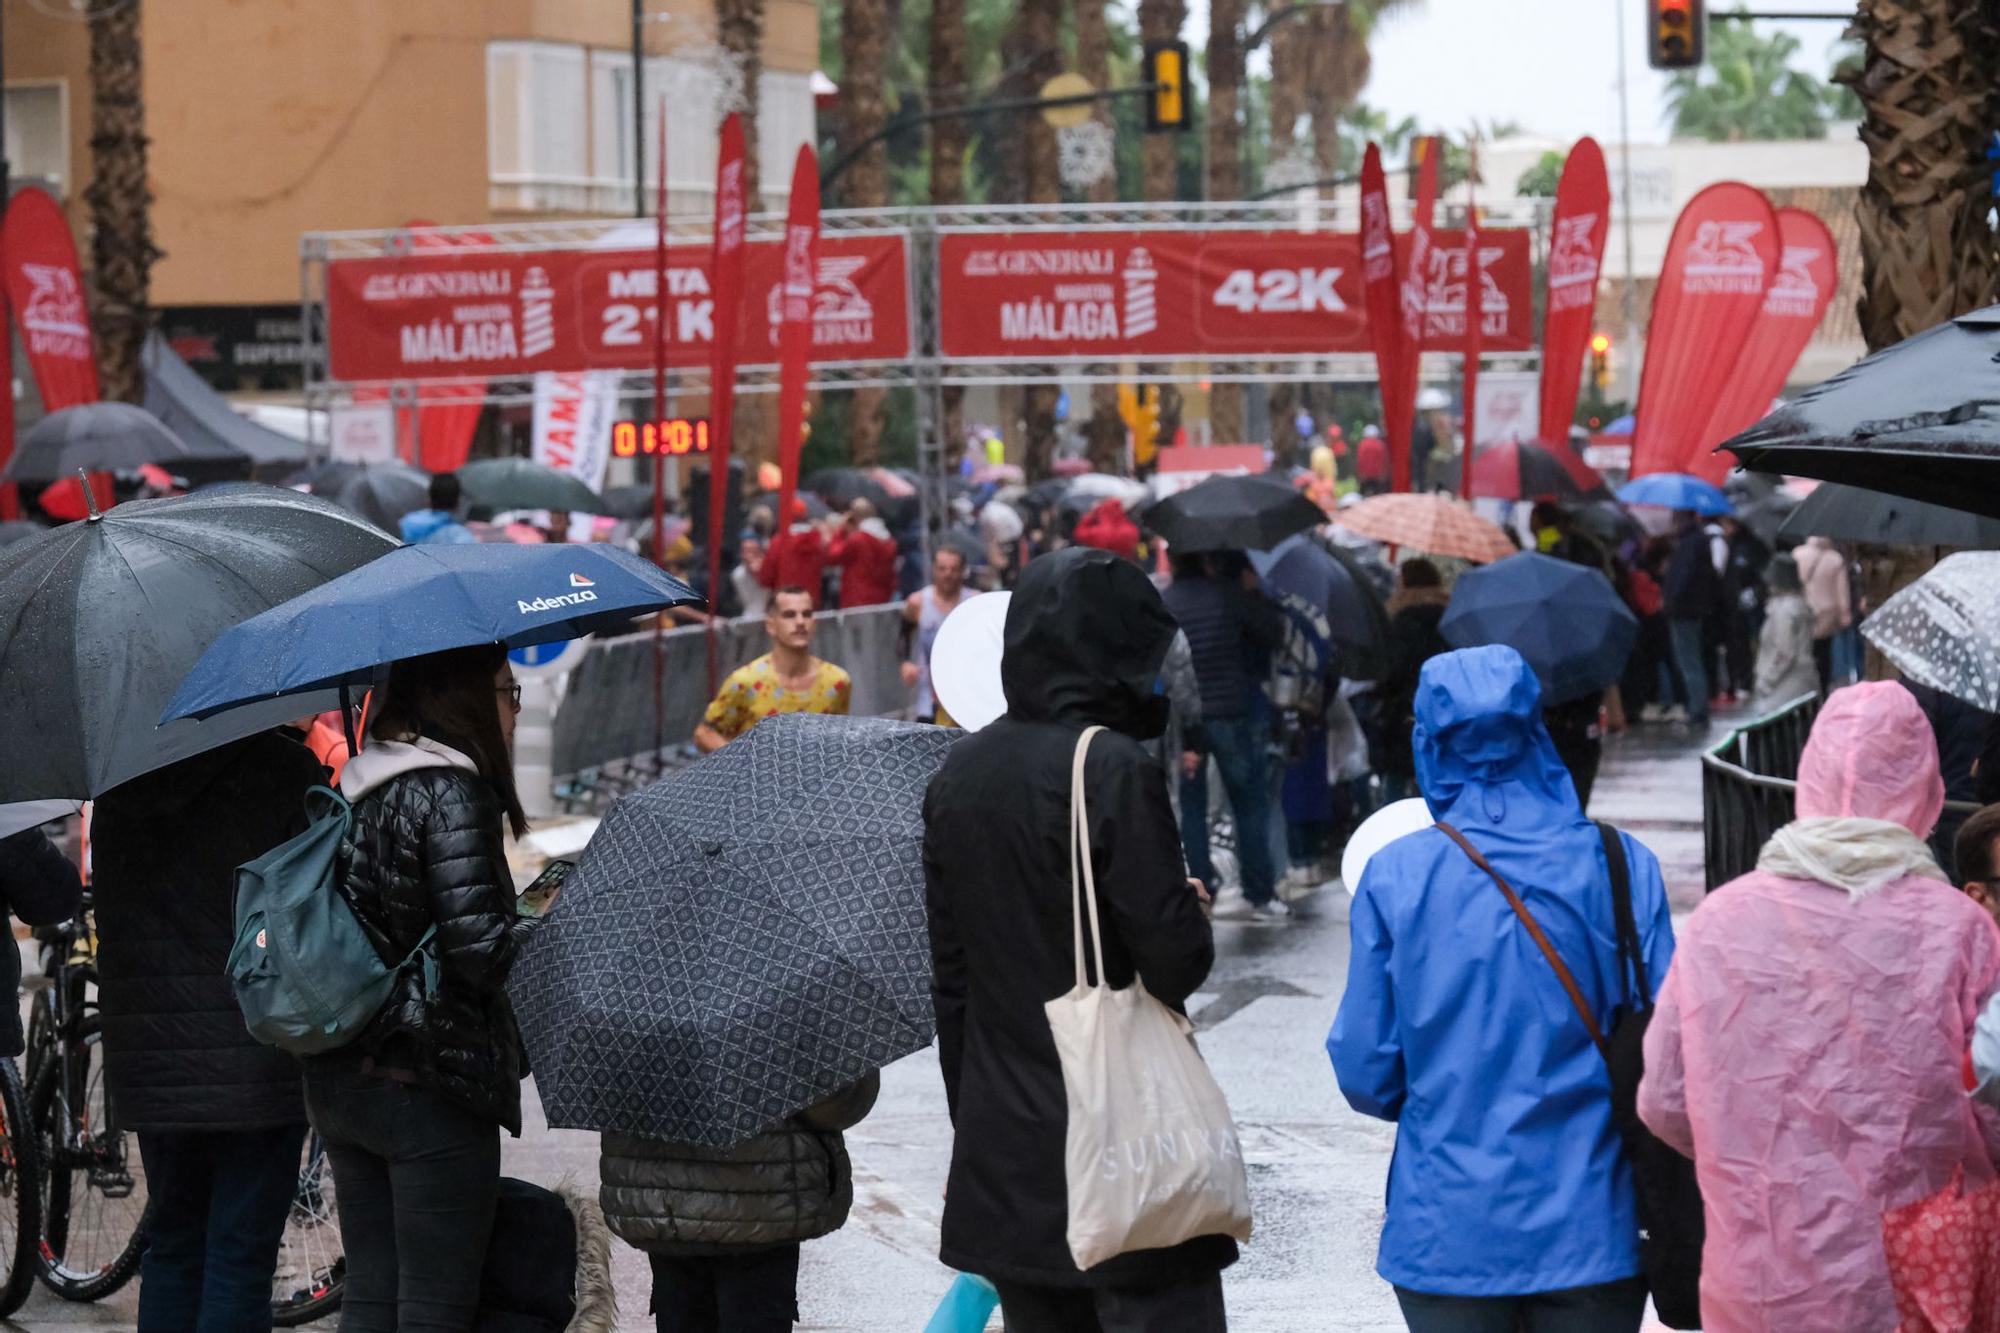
[1798,681,1944,839]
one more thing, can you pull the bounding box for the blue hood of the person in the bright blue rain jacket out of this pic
[1410,644,1582,825]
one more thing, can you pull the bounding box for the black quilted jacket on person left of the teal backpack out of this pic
[90,733,326,1131]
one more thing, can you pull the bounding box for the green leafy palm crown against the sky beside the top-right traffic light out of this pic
[1666,22,1830,144]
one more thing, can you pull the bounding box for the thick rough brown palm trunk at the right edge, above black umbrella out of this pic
[1848,0,2000,348]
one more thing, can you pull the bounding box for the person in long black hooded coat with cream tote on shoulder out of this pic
[924,548,1236,1333]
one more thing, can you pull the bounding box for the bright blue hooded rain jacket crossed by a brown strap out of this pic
[1326,644,1674,1295]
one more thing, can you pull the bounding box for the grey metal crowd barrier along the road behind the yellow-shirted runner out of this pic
[550,602,912,811]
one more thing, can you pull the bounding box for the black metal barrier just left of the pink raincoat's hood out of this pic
[1702,695,1980,891]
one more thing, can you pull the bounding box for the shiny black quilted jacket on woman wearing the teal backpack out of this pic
[316,752,530,1135]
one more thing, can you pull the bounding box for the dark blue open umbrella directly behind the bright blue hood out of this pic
[1438,554,1638,705]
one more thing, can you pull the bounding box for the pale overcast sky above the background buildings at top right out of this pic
[1188,0,1842,142]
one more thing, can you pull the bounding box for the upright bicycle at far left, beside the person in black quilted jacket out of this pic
[26,893,146,1301]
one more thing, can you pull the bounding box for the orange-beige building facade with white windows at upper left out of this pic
[0,0,818,388]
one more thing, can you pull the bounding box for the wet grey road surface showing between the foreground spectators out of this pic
[0,719,1726,1333]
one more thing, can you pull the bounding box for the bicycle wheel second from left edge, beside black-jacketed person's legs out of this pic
[28,1015,146,1301]
